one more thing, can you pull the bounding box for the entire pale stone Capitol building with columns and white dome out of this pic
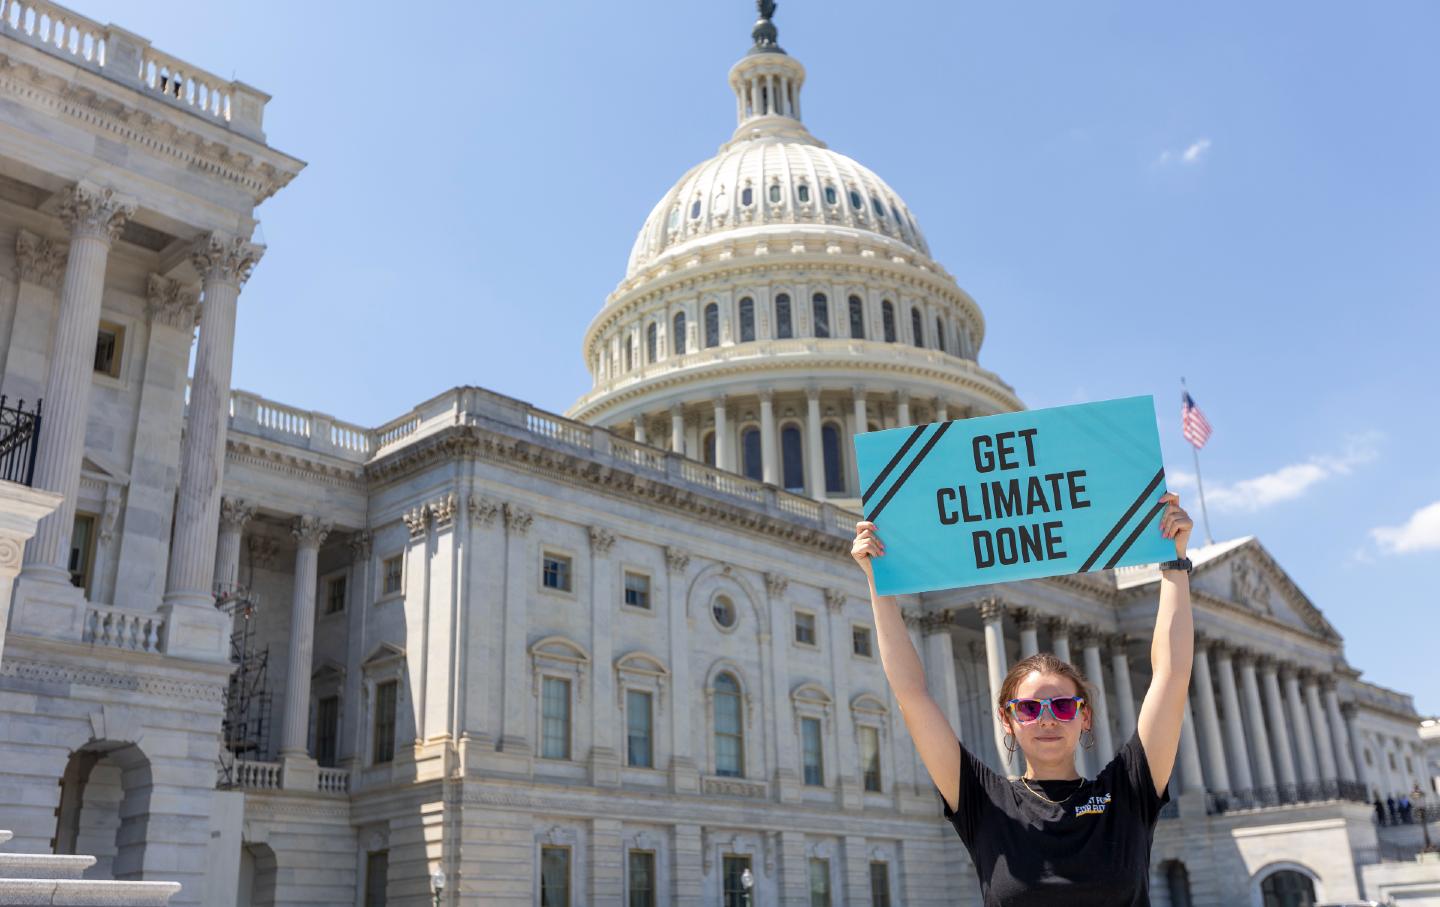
[0,0,1440,907]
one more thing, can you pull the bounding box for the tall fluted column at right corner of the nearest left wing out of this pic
[164,233,262,659]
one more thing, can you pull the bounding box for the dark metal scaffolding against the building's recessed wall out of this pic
[215,585,271,788]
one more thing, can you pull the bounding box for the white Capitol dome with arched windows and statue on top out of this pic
[567,0,1022,507]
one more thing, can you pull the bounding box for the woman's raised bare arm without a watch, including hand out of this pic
[850,521,960,812]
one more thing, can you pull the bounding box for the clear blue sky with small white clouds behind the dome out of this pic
[73,0,1440,714]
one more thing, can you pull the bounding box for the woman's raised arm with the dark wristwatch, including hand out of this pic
[1139,494,1195,793]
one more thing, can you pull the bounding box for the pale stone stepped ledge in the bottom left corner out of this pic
[0,831,180,907]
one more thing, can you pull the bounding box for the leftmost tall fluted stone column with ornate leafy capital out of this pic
[24,181,135,595]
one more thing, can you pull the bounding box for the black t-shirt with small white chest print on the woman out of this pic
[940,733,1169,907]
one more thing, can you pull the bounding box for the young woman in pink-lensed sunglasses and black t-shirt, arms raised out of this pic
[851,494,1195,907]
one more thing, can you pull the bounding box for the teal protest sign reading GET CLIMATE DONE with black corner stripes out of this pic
[855,396,1175,595]
